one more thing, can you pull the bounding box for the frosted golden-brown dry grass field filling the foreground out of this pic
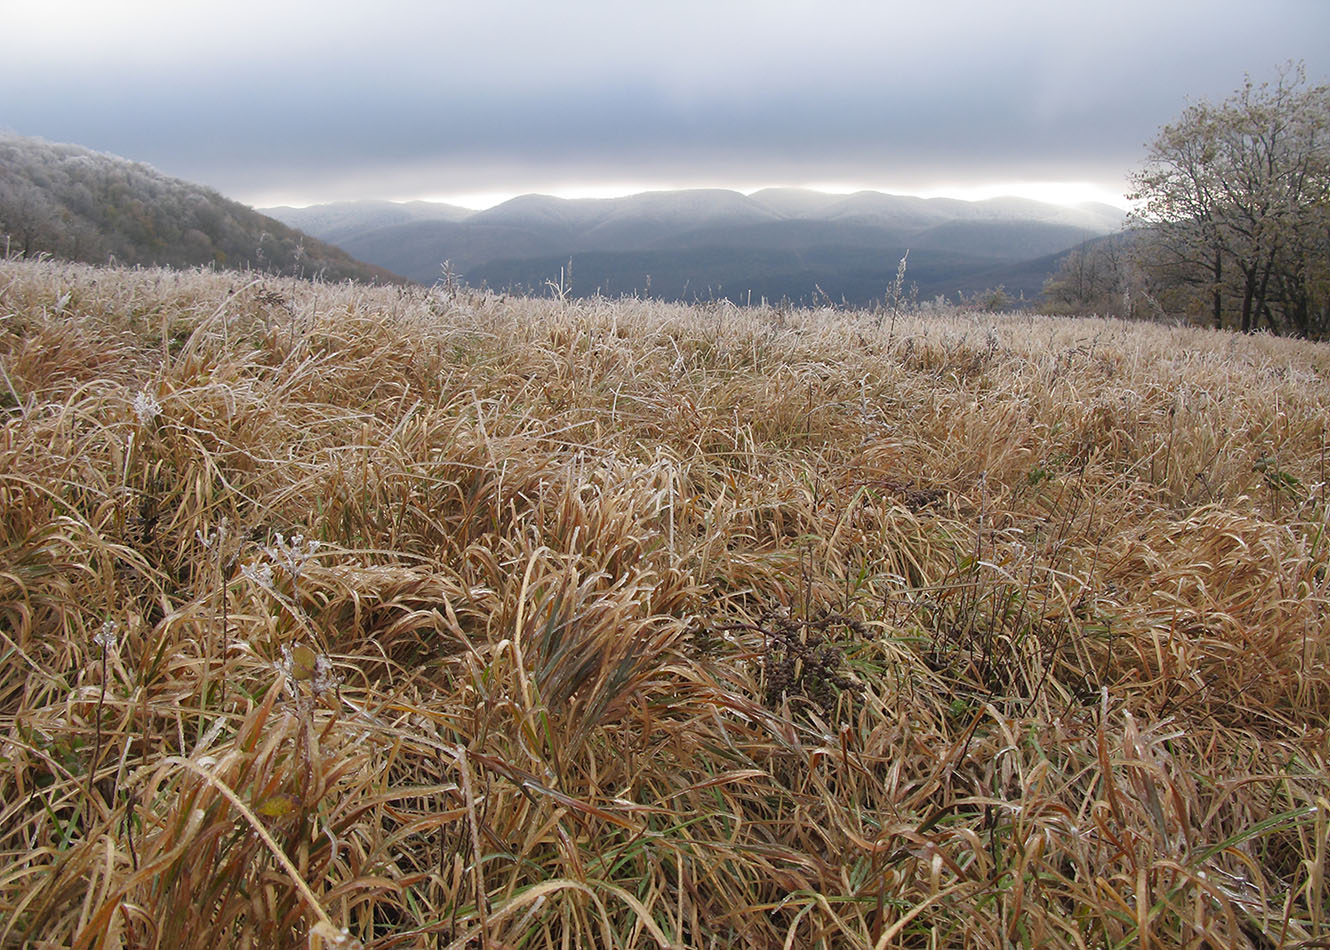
[0,261,1330,950]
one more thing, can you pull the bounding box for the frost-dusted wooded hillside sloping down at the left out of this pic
[0,132,403,283]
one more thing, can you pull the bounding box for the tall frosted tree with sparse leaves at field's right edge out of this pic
[1132,67,1330,335]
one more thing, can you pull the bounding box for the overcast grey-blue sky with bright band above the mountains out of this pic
[0,0,1330,208]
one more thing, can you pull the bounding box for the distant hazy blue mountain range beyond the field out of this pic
[265,189,1125,305]
